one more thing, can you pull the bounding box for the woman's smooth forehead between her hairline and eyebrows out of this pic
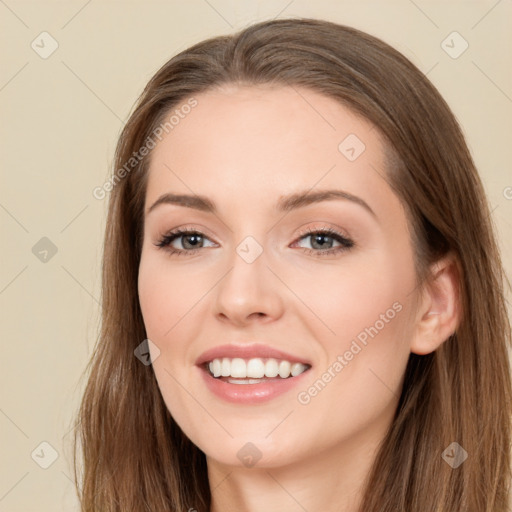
[146,85,397,218]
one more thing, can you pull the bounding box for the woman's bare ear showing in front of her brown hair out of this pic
[411,253,461,355]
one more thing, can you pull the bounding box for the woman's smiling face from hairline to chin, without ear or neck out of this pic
[139,86,415,467]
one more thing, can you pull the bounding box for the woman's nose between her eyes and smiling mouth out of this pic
[211,245,284,327]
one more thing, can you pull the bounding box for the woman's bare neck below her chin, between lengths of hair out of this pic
[208,424,382,512]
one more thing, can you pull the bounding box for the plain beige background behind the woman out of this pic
[0,0,512,512]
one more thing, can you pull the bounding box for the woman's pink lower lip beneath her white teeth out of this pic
[199,368,310,404]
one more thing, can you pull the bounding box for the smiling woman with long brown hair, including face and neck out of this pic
[73,19,511,512]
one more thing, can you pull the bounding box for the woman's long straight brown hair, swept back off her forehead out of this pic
[74,19,511,512]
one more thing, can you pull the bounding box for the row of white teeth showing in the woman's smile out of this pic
[204,357,308,384]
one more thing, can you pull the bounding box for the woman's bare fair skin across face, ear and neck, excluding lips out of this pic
[139,86,457,512]
